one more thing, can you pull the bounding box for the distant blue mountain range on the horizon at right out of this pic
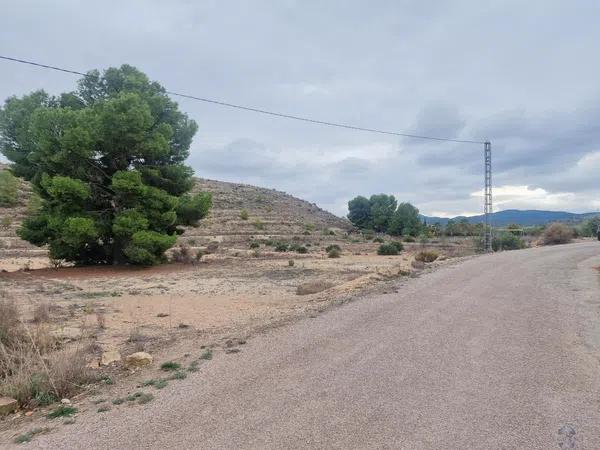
[423,209,600,227]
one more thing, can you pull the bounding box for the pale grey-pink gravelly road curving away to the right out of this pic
[30,242,600,449]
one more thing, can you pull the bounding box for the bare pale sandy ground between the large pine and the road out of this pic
[0,252,432,362]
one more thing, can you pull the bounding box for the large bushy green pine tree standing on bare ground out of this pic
[0,65,211,264]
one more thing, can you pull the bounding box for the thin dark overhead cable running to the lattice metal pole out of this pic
[0,55,485,144]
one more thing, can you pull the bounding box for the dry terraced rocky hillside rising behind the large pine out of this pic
[0,164,352,256]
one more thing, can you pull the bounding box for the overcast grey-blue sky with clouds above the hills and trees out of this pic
[0,0,600,216]
